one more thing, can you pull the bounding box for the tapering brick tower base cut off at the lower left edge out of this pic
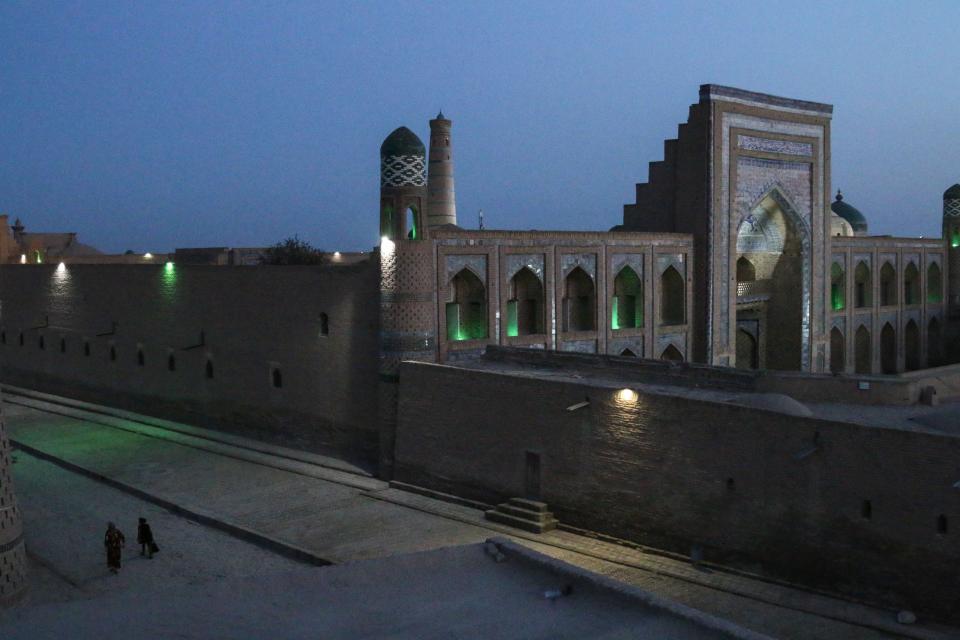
[0,394,27,607]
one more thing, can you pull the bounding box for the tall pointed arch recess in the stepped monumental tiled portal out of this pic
[736,188,810,371]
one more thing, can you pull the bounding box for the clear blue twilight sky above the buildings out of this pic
[0,0,960,252]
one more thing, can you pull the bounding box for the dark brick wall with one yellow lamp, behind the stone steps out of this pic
[395,363,960,617]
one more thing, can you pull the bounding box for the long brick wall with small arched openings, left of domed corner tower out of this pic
[0,260,379,455]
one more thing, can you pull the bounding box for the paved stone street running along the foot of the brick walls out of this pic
[6,393,958,640]
